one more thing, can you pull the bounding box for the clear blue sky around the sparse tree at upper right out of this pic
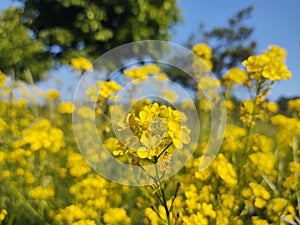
[0,0,300,100]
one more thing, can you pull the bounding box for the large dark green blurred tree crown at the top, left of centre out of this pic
[20,0,180,63]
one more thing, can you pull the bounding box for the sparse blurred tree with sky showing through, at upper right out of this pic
[189,6,256,78]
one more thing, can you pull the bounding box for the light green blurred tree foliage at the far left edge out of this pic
[0,7,53,82]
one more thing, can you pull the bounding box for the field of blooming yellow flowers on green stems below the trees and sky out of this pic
[0,43,300,225]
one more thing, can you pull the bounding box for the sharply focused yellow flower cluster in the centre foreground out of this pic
[113,103,191,160]
